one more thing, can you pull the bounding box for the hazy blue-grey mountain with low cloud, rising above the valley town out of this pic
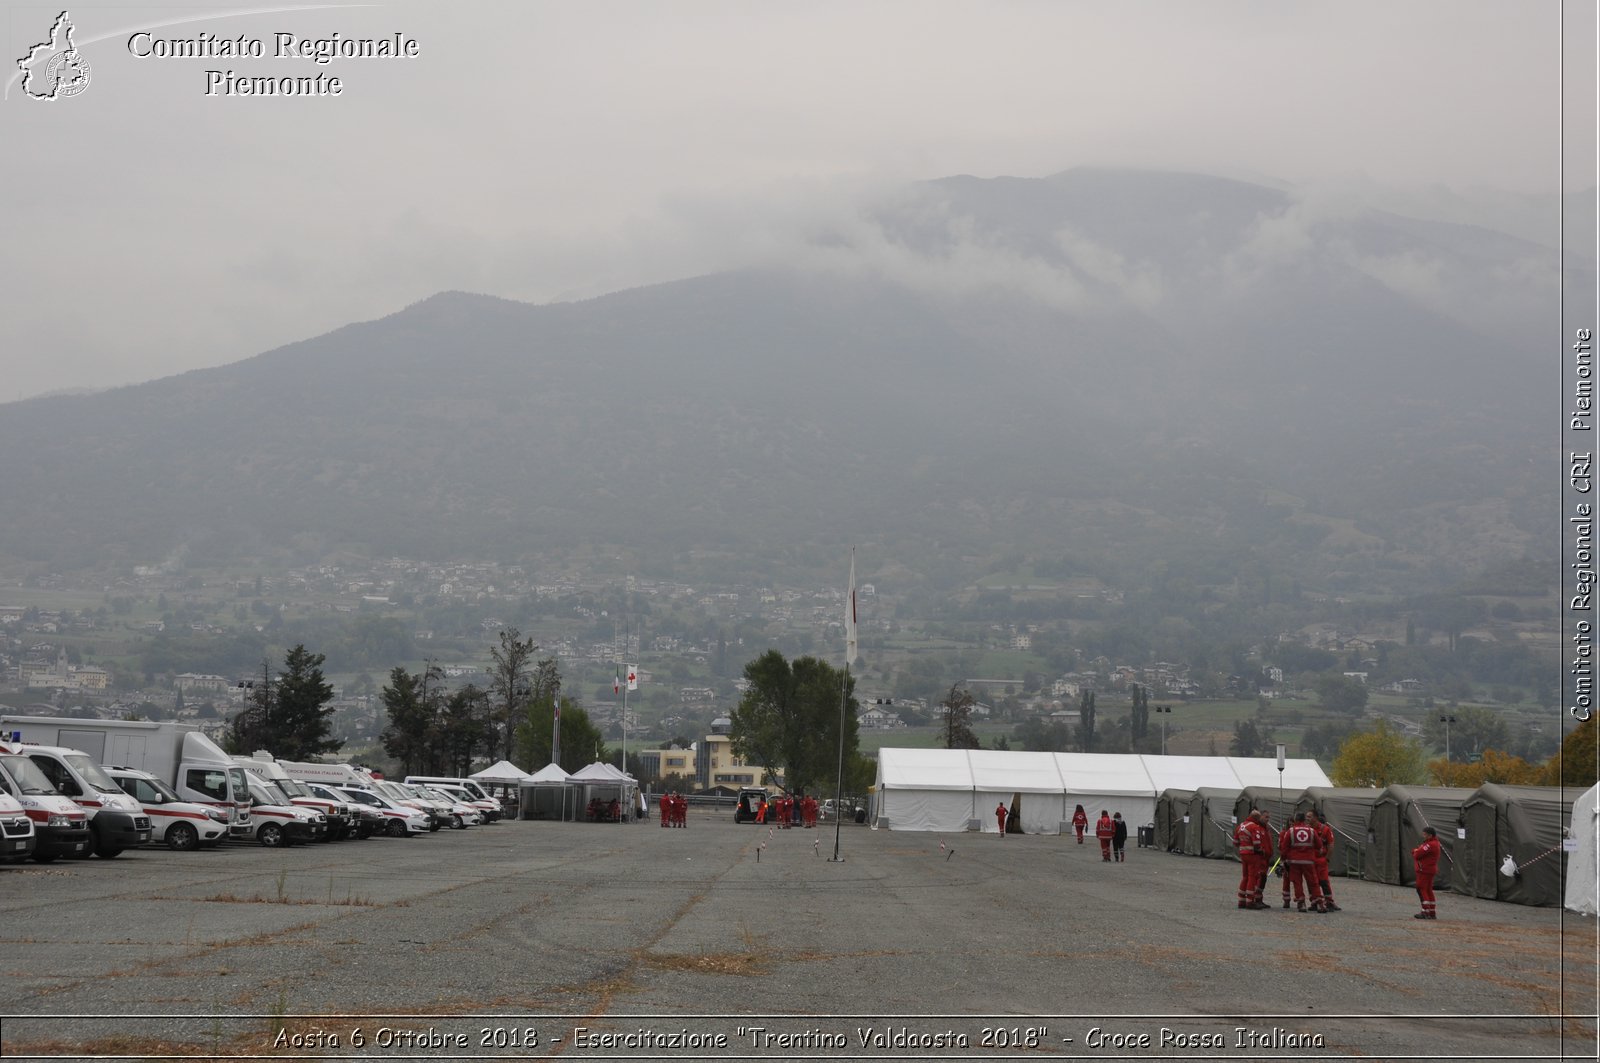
[0,170,1574,589]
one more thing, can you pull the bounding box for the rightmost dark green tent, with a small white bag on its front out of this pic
[1459,783,1573,908]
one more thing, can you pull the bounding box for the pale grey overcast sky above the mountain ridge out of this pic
[0,0,1595,402]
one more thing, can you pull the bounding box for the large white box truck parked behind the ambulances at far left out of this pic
[0,716,254,839]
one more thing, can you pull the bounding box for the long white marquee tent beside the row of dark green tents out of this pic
[874,748,1330,834]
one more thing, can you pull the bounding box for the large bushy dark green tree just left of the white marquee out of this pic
[731,650,861,792]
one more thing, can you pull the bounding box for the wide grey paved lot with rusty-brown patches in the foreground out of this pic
[0,812,1597,1060]
